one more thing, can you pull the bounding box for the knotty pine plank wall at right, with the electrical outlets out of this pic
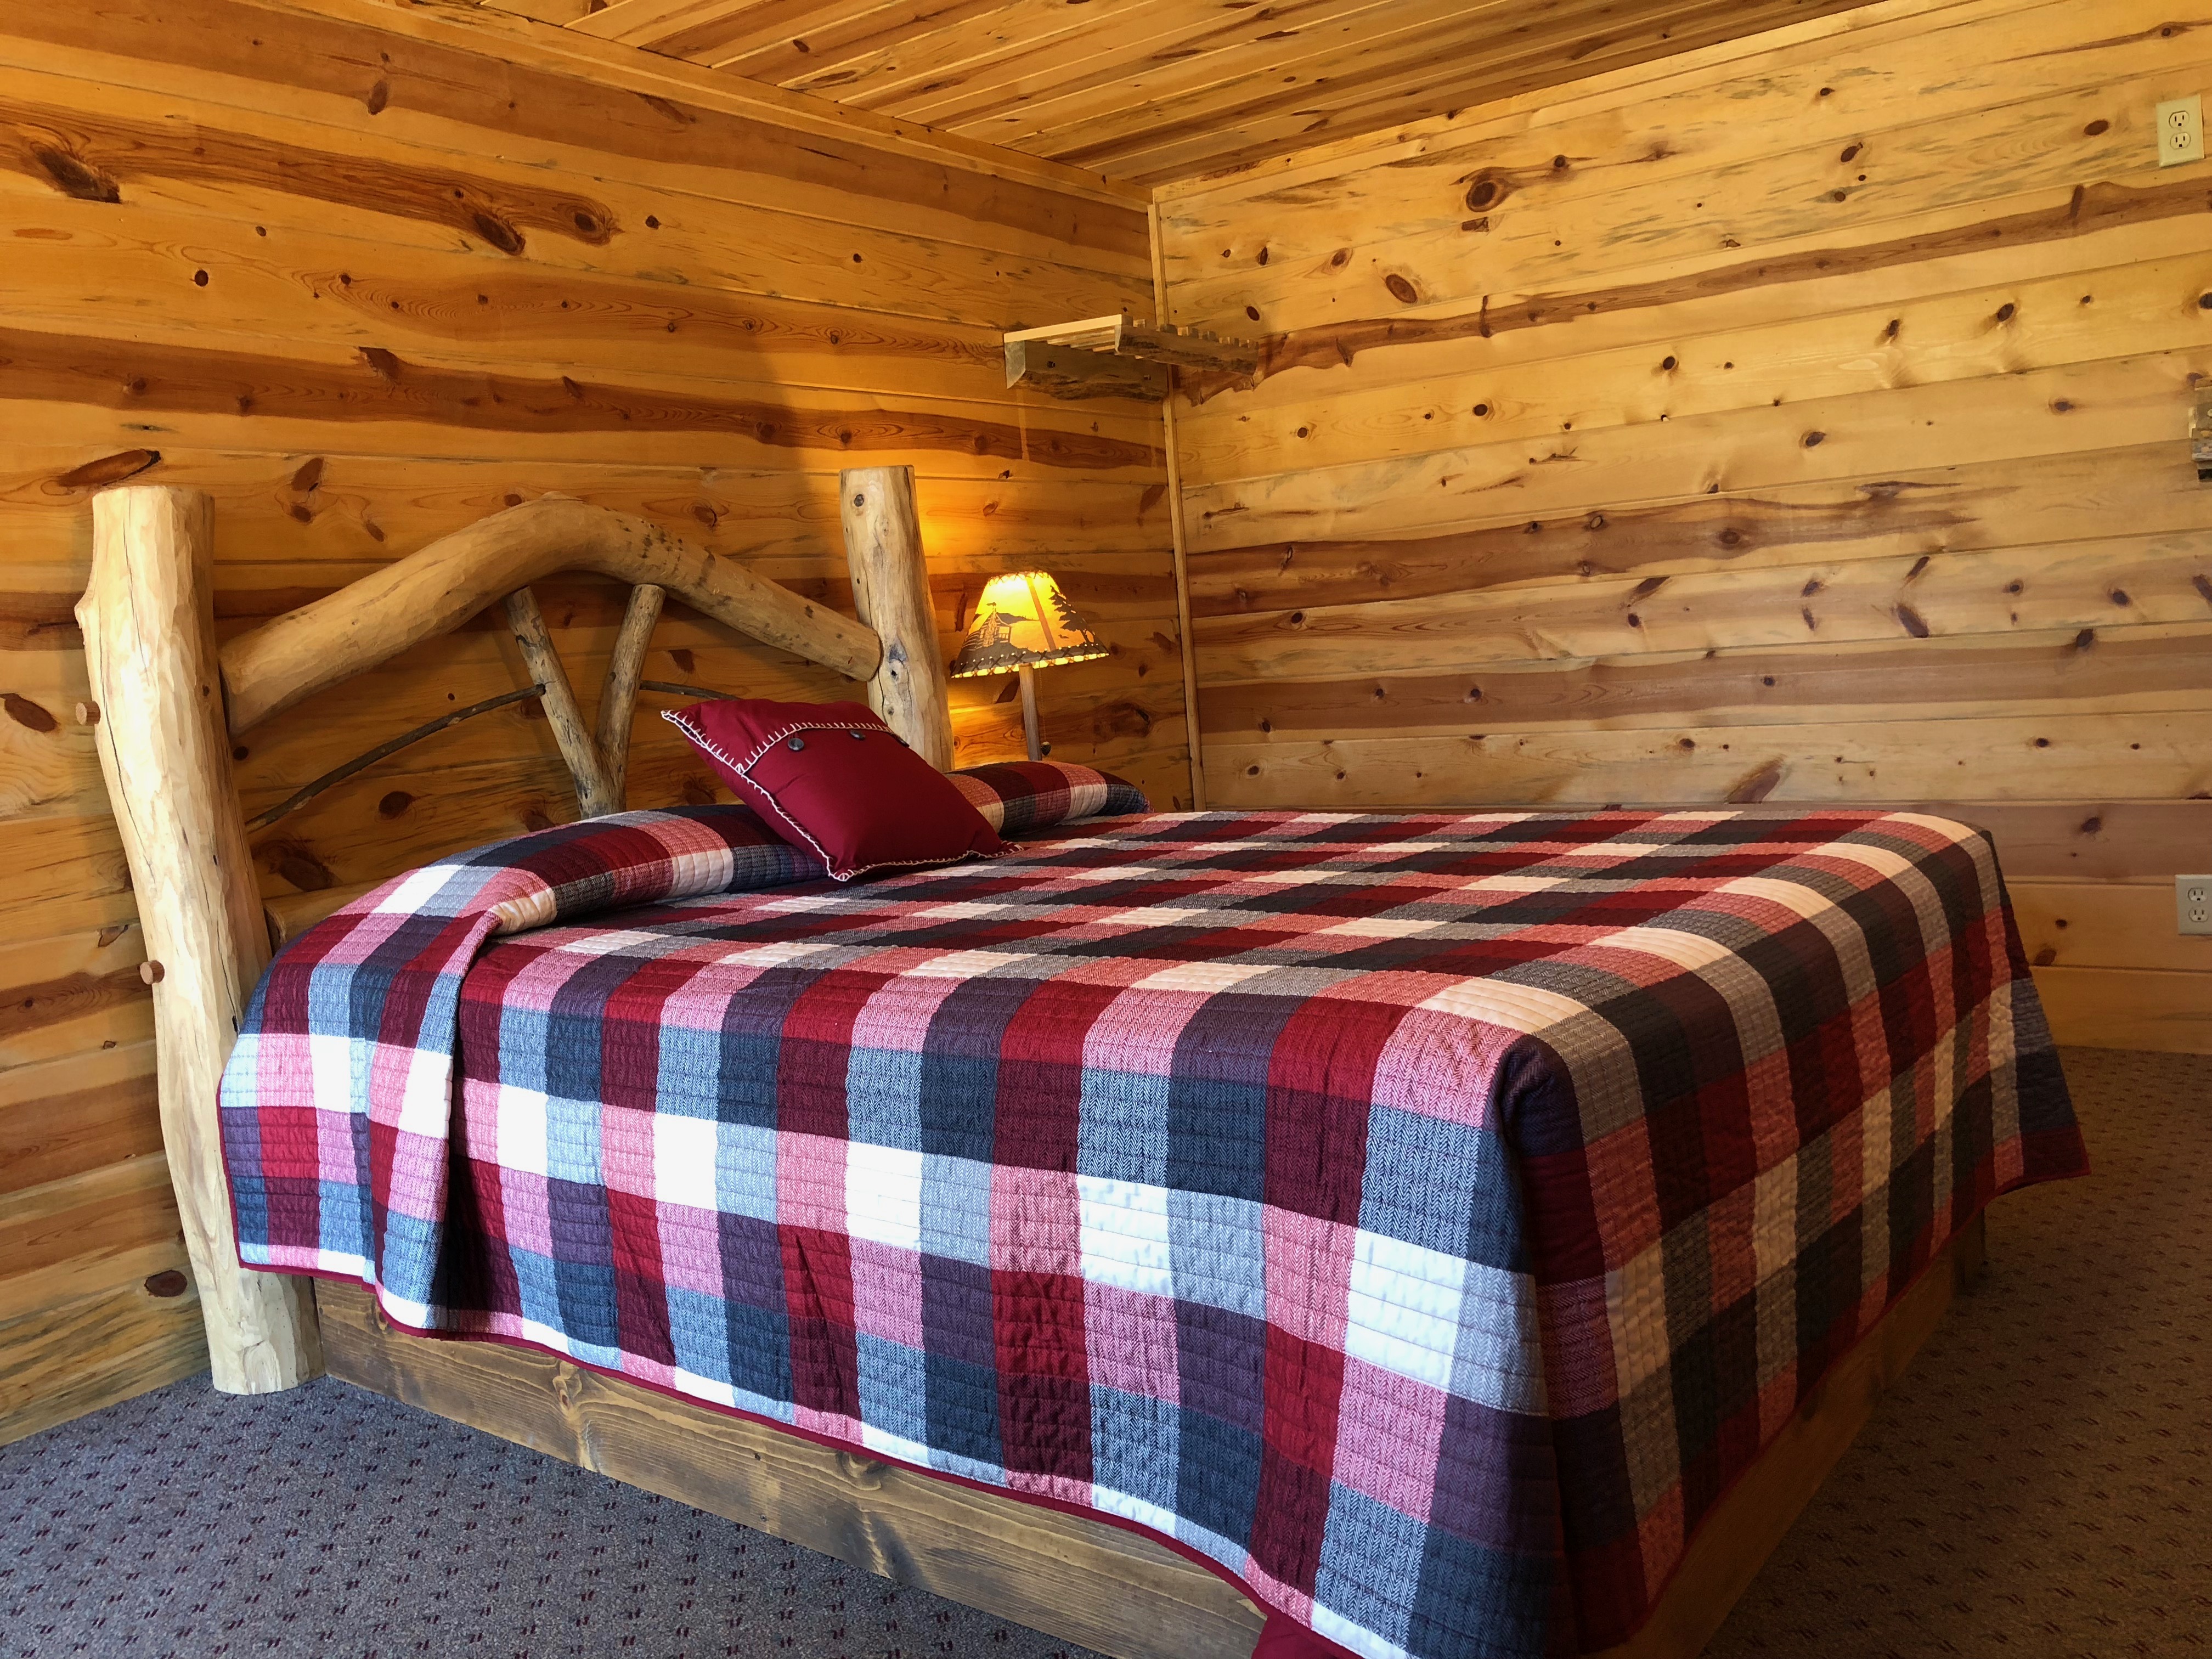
[1157,0,2212,1053]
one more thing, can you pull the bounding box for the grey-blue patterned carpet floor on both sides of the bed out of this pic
[0,1051,2212,1659]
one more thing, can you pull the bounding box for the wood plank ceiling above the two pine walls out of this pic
[484,0,1860,184]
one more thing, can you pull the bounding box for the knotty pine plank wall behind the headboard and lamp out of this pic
[0,0,1190,1440]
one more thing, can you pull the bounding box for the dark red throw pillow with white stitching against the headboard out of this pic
[662,697,1007,881]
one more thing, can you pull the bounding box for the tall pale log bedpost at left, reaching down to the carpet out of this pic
[77,484,323,1393]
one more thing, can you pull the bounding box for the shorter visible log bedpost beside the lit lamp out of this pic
[836,467,953,770]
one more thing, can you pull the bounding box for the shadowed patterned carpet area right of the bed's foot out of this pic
[1706,1048,2212,1659]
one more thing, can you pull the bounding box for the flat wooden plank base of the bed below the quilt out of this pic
[317,1217,1984,1659]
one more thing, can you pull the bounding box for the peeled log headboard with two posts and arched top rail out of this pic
[77,467,953,1393]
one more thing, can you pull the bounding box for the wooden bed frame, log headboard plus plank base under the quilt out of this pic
[77,467,1984,1659]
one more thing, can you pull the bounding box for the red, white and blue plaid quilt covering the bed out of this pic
[221,808,2084,1659]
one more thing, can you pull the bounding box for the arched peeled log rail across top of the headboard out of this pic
[223,495,883,735]
